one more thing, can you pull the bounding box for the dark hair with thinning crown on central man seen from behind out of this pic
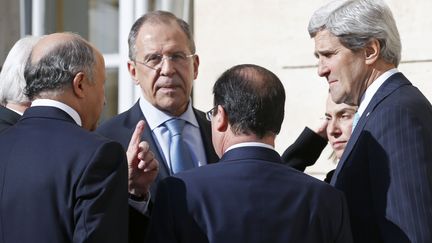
[213,64,285,138]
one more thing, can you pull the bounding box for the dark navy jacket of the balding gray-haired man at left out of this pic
[0,107,128,243]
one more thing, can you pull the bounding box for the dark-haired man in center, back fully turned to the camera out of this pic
[149,64,351,243]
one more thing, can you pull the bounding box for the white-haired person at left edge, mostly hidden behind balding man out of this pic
[0,36,39,132]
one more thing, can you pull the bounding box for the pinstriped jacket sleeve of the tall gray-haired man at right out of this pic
[368,107,432,242]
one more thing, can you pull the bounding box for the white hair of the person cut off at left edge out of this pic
[0,36,40,106]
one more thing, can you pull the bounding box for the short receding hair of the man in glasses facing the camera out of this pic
[128,10,195,61]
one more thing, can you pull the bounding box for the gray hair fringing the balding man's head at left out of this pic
[24,33,96,100]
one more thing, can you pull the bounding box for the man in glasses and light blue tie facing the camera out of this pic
[97,11,219,242]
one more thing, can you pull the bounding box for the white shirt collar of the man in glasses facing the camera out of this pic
[139,96,199,130]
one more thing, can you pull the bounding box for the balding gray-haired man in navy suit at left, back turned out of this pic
[0,33,128,243]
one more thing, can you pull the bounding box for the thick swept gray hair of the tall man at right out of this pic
[308,0,402,67]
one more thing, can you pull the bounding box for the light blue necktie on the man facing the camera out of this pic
[165,119,194,174]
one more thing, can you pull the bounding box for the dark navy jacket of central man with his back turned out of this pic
[149,147,352,243]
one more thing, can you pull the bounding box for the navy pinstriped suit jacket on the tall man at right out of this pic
[332,73,432,243]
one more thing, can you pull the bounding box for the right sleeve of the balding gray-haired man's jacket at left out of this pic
[73,142,128,243]
